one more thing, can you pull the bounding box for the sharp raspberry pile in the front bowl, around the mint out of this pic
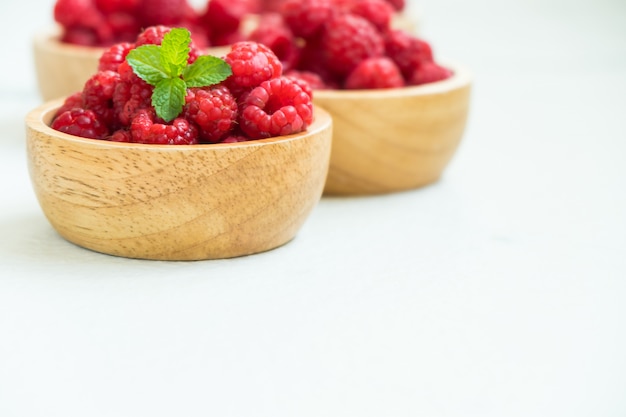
[51,26,313,145]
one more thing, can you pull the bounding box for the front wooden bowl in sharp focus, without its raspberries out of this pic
[26,99,332,260]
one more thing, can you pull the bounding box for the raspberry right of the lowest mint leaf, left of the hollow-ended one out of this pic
[183,85,237,143]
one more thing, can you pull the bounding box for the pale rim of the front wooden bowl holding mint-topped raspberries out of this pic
[25,97,332,152]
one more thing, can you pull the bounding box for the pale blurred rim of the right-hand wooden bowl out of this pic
[313,61,473,101]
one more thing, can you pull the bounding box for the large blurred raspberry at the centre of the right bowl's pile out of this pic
[322,14,385,76]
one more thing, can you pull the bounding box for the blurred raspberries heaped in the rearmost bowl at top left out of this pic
[54,0,404,48]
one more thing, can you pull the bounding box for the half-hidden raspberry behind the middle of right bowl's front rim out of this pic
[344,57,405,90]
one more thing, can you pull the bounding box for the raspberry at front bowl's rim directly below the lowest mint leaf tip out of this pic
[130,110,198,145]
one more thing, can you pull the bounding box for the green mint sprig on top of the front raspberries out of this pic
[126,28,232,122]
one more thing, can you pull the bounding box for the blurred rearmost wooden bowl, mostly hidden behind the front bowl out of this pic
[33,28,230,101]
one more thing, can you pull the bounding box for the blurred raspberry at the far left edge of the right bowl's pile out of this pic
[248,13,300,71]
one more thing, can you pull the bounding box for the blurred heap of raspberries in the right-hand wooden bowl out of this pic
[248,0,452,90]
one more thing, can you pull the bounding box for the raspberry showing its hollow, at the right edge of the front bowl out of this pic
[239,77,313,139]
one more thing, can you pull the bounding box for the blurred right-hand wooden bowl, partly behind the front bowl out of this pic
[313,65,471,195]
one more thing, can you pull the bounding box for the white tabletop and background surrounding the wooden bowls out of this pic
[0,0,626,417]
